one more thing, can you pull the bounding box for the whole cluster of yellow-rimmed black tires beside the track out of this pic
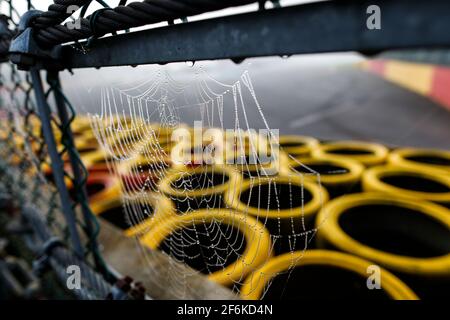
[65,115,450,299]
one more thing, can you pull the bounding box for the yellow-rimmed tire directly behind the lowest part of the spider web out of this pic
[141,209,272,286]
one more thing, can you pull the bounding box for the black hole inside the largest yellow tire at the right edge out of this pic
[339,204,450,258]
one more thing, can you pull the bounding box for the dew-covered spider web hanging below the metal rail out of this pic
[89,67,323,298]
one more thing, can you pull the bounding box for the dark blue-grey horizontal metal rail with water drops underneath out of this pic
[61,0,450,69]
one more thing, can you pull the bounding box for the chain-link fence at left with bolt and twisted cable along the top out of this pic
[0,0,278,299]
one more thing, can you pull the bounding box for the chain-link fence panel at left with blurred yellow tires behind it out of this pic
[0,0,114,299]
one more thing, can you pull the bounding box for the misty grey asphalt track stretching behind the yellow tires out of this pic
[63,54,450,149]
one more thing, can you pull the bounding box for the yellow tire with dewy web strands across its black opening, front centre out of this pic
[141,209,272,286]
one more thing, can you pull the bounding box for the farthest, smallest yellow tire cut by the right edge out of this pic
[388,148,450,175]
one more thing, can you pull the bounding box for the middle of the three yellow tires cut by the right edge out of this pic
[362,166,450,206]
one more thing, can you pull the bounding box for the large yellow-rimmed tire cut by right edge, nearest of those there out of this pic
[316,193,450,279]
